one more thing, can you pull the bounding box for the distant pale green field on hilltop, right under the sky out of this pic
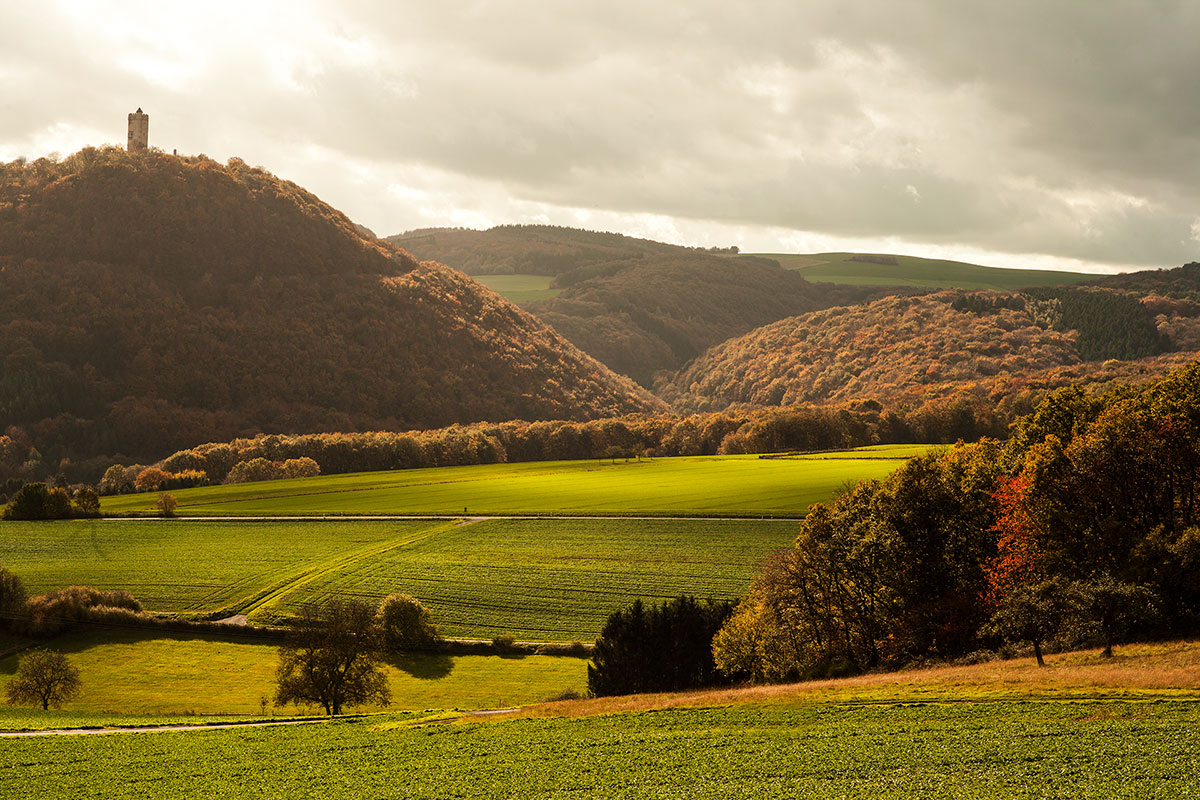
[756,253,1099,290]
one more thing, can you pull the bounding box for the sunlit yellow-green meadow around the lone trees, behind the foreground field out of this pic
[0,631,587,728]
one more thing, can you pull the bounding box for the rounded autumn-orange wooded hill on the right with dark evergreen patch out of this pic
[656,288,1194,410]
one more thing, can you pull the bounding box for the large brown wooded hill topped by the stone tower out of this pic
[0,148,660,476]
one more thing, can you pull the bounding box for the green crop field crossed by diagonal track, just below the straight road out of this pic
[0,519,796,642]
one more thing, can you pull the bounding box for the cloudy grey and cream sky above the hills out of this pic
[0,0,1200,272]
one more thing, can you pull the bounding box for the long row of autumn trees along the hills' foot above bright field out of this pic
[121,398,1008,493]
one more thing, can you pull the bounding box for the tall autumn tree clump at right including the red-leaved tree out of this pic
[714,363,1200,680]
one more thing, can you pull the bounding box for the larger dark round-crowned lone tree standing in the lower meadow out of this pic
[275,597,391,715]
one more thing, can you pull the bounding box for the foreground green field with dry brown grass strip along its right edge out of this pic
[0,643,1200,799]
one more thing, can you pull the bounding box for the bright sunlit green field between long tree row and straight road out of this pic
[102,445,929,517]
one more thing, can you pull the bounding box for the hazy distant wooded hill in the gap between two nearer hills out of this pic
[390,225,892,386]
